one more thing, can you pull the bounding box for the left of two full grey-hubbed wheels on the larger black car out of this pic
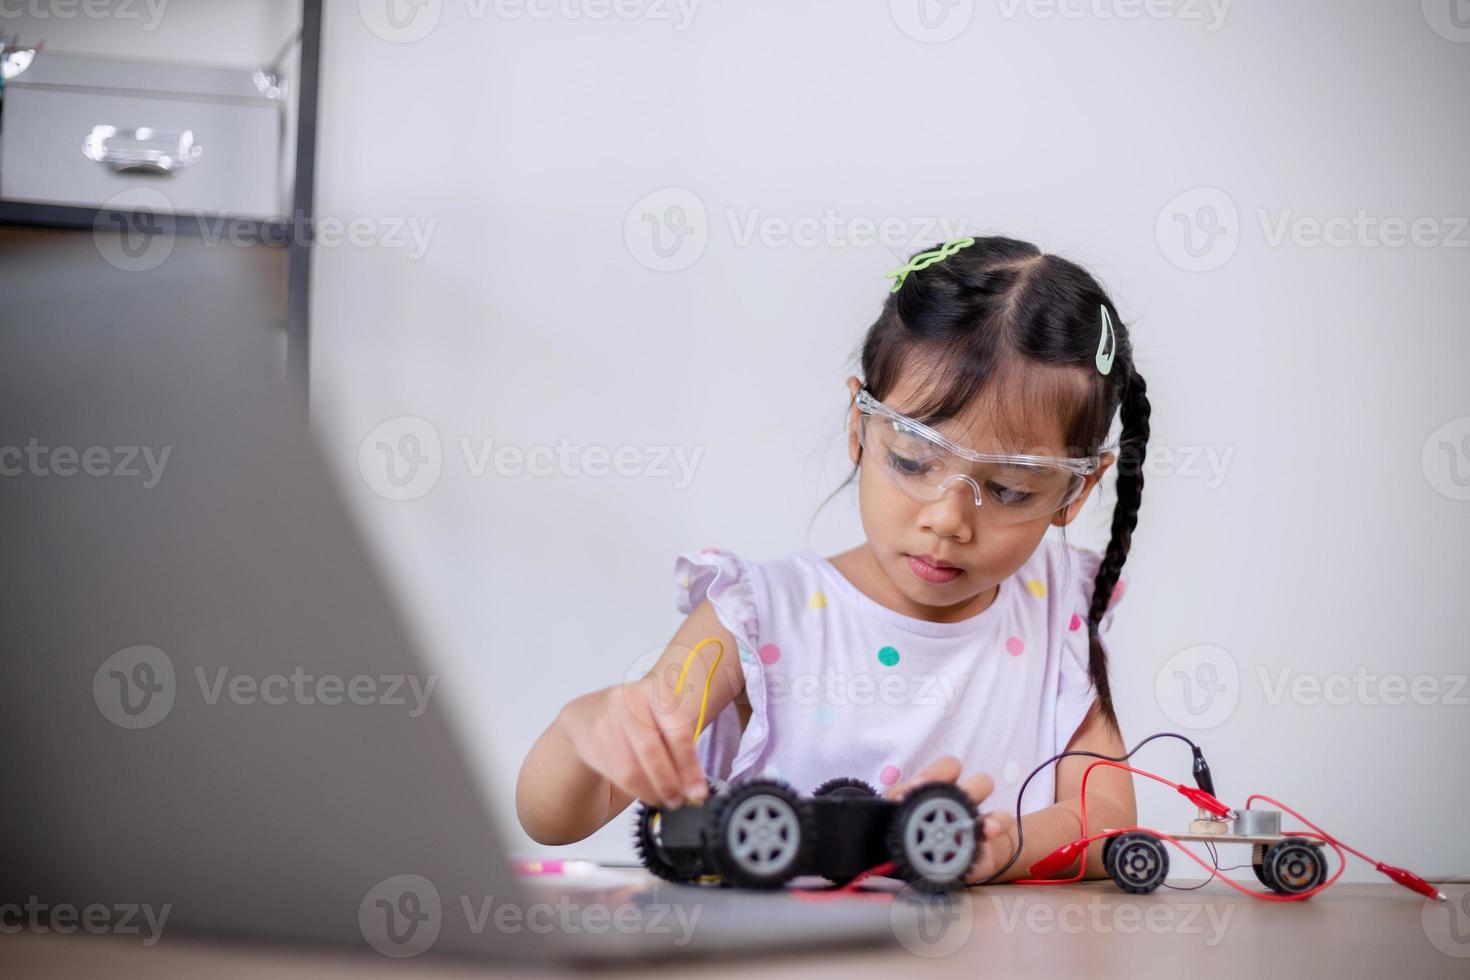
[704,779,816,889]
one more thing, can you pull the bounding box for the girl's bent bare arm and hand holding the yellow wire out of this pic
[516,599,745,845]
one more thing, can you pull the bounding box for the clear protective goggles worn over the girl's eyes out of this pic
[857,388,1101,523]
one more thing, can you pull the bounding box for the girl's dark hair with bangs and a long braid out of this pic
[823,238,1150,726]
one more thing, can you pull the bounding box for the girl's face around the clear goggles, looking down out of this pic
[847,372,1113,623]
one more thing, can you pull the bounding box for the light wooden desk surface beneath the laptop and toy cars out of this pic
[11,871,1470,980]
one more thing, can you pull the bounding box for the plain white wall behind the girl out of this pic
[313,0,1470,876]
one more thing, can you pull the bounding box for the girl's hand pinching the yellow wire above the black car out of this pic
[557,674,709,808]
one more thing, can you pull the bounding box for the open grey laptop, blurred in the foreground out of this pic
[0,232,908,961]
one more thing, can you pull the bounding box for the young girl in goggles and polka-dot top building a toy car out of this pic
[516,238,1150,882]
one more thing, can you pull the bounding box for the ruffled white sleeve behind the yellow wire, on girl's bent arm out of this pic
[673,548,769,782]
